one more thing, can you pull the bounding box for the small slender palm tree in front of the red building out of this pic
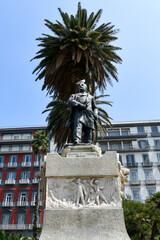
[32,130,49,238]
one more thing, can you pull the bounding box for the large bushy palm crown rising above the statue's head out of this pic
[32,3,122,101]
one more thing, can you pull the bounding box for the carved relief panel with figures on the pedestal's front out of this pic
[46,177,121,209]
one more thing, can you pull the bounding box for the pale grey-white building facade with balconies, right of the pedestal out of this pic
[98,120,160,202]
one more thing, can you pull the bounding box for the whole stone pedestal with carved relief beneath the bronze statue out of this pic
[40,146,130,240]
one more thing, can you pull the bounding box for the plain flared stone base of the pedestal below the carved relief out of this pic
[40,208,130,240]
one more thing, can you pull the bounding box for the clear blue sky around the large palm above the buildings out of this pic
[0,0,160,127]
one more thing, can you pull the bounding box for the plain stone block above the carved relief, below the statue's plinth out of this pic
[46,151,118,177]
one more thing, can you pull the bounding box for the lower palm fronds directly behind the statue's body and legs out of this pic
[43,95,112,150]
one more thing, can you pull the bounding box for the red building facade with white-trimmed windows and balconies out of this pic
[0,127,46,234]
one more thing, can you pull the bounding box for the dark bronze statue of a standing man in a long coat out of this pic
[67,79,98,144]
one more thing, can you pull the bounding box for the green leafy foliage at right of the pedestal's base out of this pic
[123,192,160,240]
